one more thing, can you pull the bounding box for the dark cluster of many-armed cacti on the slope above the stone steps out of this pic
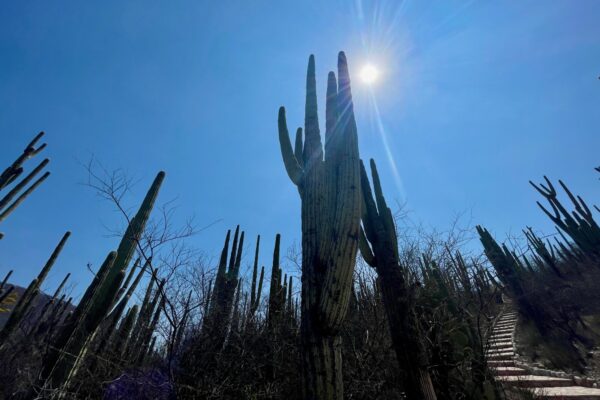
[477,168,600,368]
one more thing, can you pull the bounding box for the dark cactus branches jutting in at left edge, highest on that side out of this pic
[0,132,50,239]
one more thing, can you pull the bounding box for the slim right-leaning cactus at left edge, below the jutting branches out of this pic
[0,232,71,349]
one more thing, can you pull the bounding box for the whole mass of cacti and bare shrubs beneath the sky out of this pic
[0,53,600,400]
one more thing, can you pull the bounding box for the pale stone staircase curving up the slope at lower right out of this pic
[486,303,600,400]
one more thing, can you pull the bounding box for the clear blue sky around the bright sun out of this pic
[0,0,600,291]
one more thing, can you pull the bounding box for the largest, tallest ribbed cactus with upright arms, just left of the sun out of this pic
[278,52,361,399]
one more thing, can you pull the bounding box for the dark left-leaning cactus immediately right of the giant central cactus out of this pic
[359,160,436,400]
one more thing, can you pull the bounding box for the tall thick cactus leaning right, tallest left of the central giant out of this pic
[42,171,165,387]
